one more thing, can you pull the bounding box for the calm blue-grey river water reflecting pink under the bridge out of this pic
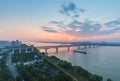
[24,43,120,81]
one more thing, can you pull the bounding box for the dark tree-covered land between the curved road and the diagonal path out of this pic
[12,49,77,81]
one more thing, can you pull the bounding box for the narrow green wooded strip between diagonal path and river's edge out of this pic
[47,56,102,81]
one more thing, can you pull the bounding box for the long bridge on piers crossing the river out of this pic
[36,43,102,53]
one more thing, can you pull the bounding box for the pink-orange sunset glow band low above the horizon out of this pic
[0,21,120,42]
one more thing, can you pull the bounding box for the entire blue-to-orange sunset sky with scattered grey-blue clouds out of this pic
[0,0,120,42]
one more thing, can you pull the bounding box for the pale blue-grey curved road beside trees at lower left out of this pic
[6,52,19,79]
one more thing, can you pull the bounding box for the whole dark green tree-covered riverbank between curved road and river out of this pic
[12,45,111,81]
